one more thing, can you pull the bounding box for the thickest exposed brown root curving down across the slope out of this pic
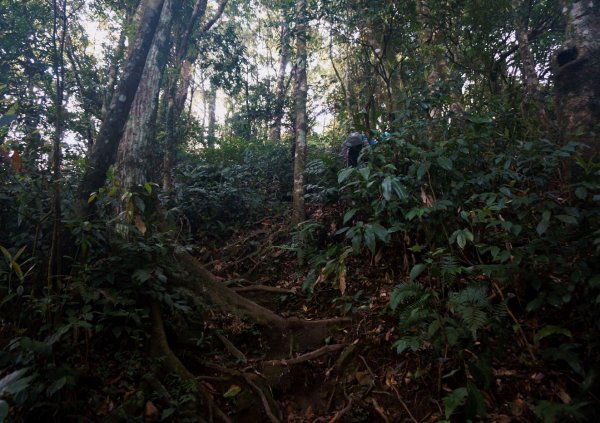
[175,250,351,352]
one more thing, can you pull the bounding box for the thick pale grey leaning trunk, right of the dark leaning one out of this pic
[116,0,172,191]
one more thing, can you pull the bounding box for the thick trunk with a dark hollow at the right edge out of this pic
[554,0,600,155]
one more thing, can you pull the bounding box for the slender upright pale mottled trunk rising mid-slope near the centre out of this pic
[292,0,308,225]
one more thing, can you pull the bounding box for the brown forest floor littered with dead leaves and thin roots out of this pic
[166,208,570,423]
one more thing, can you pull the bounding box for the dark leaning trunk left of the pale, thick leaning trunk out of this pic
[79,0,164,211]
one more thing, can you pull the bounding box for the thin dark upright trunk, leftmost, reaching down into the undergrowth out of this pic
[48,0,67,286]
